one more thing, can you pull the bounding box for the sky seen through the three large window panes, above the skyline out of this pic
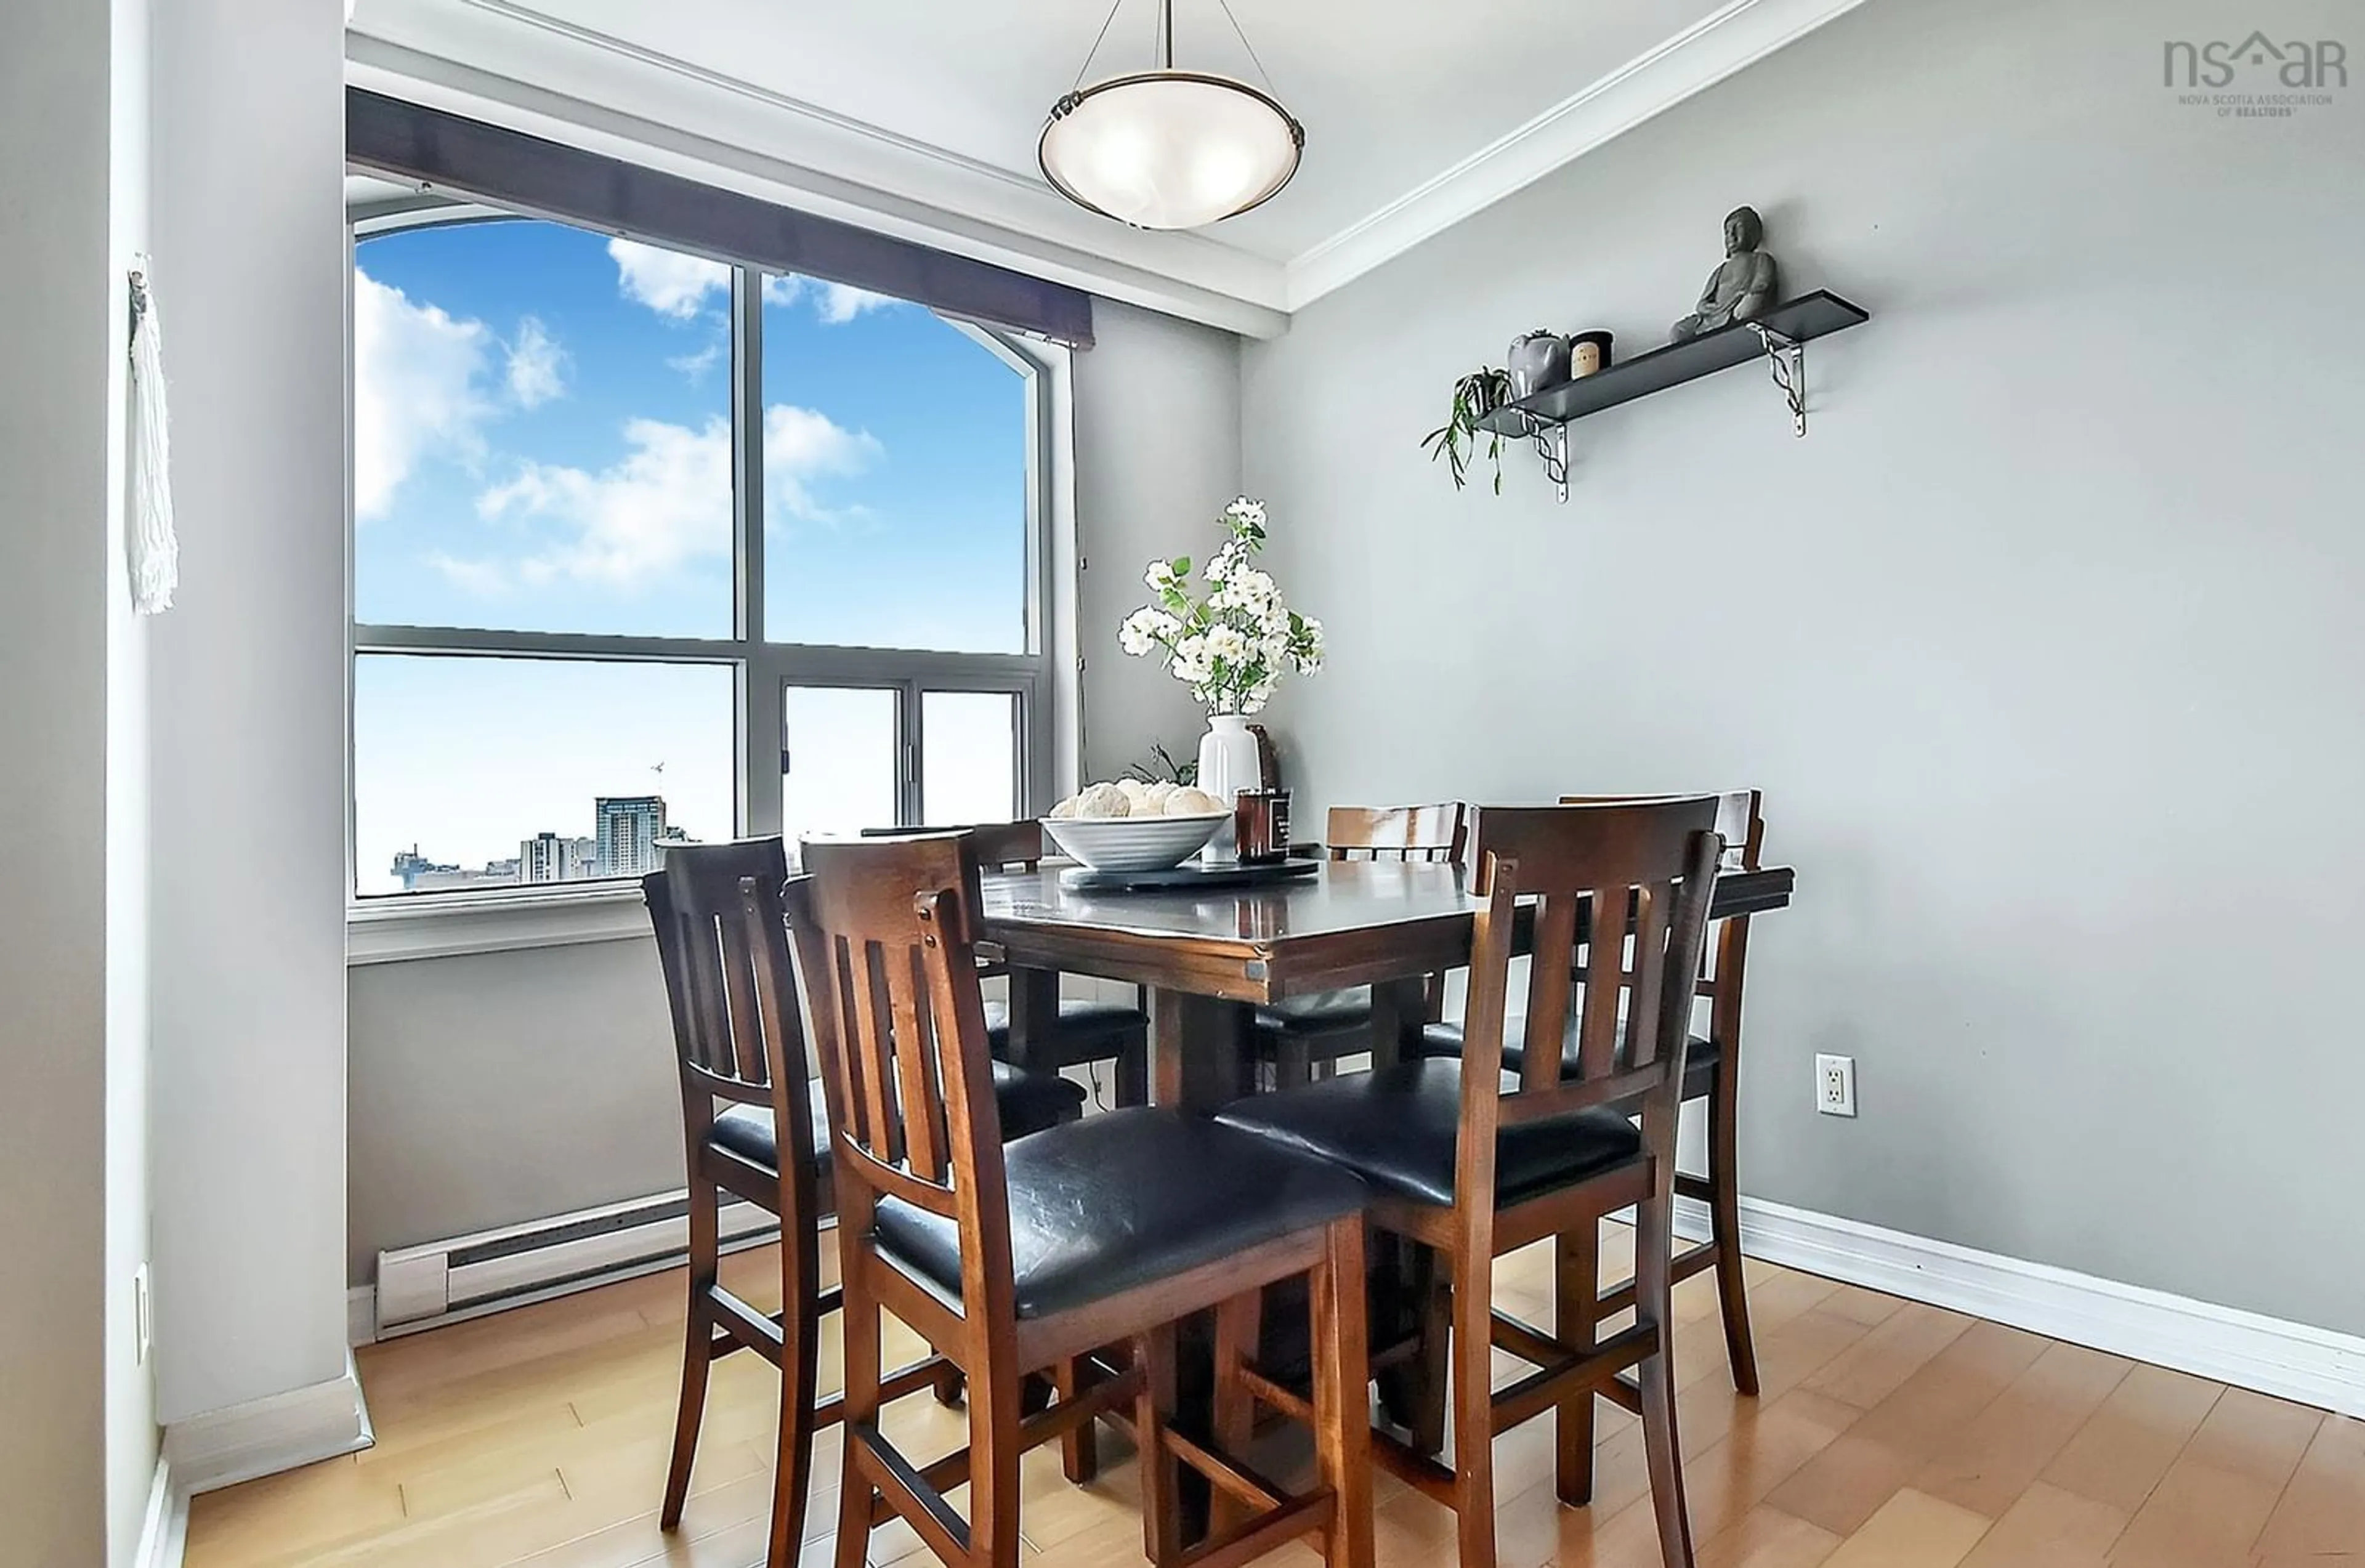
[355,220,1027,892]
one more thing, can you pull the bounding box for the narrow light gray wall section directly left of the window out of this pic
[152,0,347,1424]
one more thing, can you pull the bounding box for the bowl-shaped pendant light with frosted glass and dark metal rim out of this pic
[1041,0,1306,229]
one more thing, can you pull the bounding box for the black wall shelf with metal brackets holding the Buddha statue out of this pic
[1478,288,1870,501]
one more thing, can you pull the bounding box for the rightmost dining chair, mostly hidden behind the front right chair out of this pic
[1421,790,1766,1398]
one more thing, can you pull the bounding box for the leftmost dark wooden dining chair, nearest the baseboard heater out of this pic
[641,837,1083,1568]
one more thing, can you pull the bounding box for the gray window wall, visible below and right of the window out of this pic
[346,303,1239,1284]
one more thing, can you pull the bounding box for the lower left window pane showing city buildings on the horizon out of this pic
[352,653,738,896]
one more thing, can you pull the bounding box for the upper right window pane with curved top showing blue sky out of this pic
[764,277,1029,653]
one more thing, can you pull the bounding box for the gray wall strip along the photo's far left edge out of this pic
[0,0,127,1568]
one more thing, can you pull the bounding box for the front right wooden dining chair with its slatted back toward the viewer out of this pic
[1218,797,1722,1568]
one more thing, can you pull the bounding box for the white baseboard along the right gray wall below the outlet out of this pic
[1675,1197,2365,1419]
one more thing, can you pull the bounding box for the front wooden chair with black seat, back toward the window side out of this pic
[794,835,1372,1568]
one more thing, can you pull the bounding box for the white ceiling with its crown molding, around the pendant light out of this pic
[352,0,1854,328]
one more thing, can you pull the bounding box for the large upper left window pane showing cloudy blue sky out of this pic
[352,220,733,636]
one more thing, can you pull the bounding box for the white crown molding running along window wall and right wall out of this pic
[347,0,1861,338]
